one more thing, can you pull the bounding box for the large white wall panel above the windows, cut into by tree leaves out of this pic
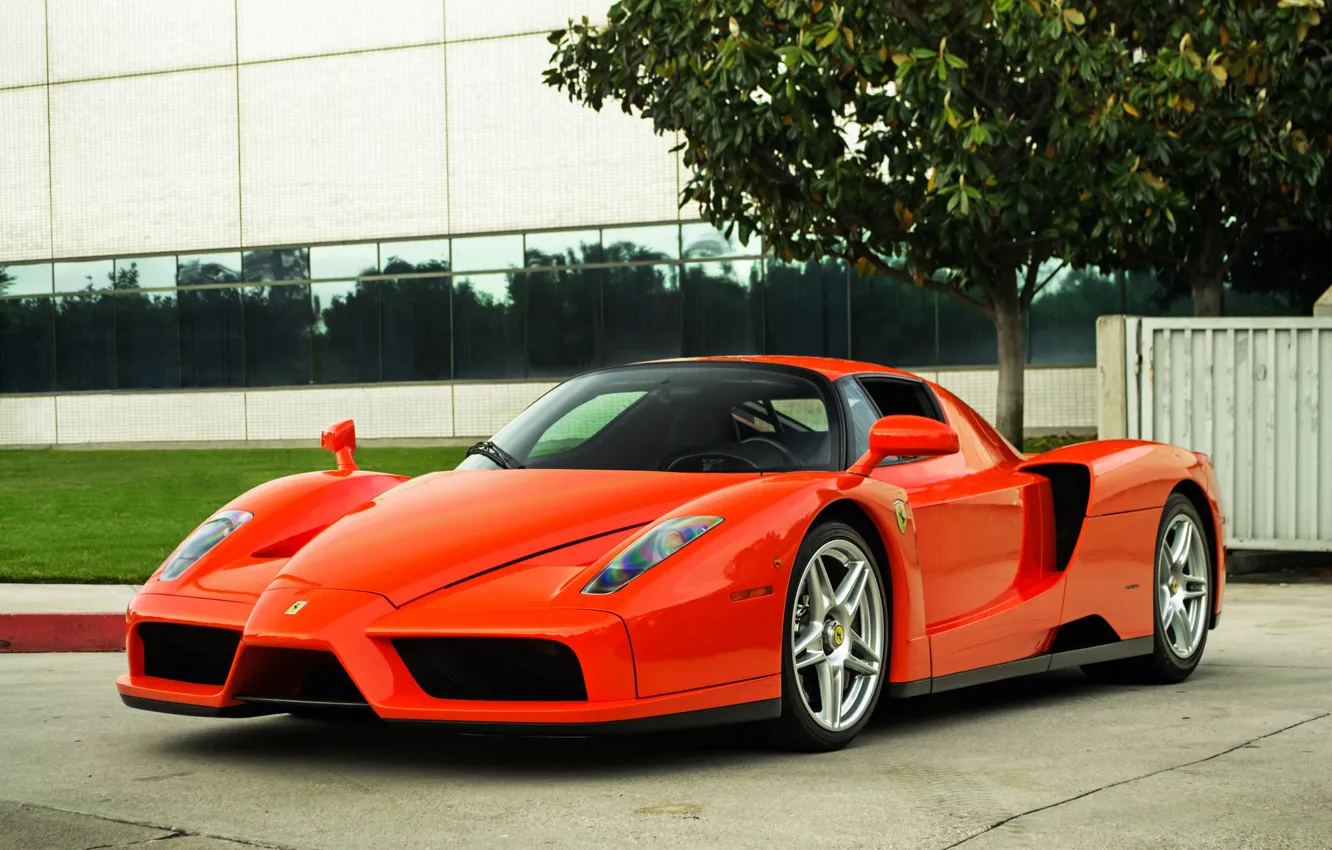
[448,35,679,233]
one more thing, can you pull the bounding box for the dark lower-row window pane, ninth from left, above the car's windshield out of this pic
[515,266,602,377]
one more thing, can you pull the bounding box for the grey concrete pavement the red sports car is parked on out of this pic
[0,584,1332,850]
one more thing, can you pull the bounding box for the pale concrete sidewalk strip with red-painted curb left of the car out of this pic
[0,584,139,653]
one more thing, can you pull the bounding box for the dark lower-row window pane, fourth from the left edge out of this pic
[177,289,245,388]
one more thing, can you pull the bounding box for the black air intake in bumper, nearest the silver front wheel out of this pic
[393,638,587,702]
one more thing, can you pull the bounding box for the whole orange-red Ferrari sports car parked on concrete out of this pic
[116,357,1225,750]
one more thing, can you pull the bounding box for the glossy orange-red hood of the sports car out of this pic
[274,469,758,606]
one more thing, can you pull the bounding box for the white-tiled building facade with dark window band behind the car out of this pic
[0,0,1113,445]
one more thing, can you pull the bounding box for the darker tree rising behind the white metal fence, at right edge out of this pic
[1106,0,1332,316]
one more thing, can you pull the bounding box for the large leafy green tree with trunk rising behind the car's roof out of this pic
[546,0,1183,445]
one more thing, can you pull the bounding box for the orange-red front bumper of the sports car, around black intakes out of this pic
[116,589,781,734]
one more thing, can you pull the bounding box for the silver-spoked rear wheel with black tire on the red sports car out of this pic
[1083,493,1215,685]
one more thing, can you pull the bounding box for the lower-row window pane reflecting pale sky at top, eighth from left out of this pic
[453,273,526,378]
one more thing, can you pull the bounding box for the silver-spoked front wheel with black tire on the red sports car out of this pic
[774,522,891,753]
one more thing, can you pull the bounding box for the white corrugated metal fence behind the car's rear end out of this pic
[1098,316,1332,552]
